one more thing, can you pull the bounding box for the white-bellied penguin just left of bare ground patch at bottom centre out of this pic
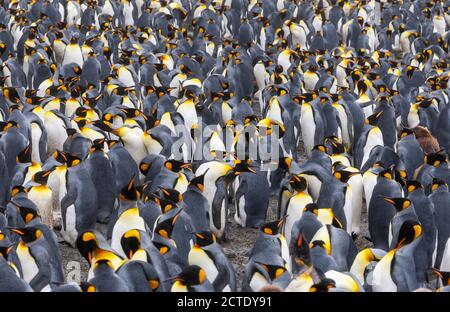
[188,231,236,292]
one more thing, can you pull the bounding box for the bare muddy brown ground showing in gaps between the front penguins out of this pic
[60,140,370,288]
